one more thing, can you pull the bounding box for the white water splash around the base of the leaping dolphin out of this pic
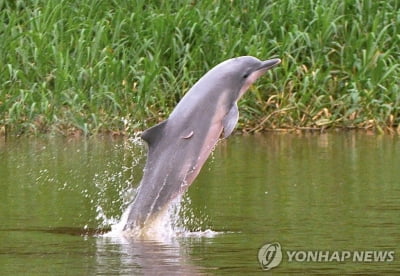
[92,133,220,242]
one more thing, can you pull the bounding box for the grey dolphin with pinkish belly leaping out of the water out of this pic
[124,56,281,230]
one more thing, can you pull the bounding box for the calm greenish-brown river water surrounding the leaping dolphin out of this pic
[0,132,400,275]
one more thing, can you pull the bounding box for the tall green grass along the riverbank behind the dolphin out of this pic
[0,0,400,135]
